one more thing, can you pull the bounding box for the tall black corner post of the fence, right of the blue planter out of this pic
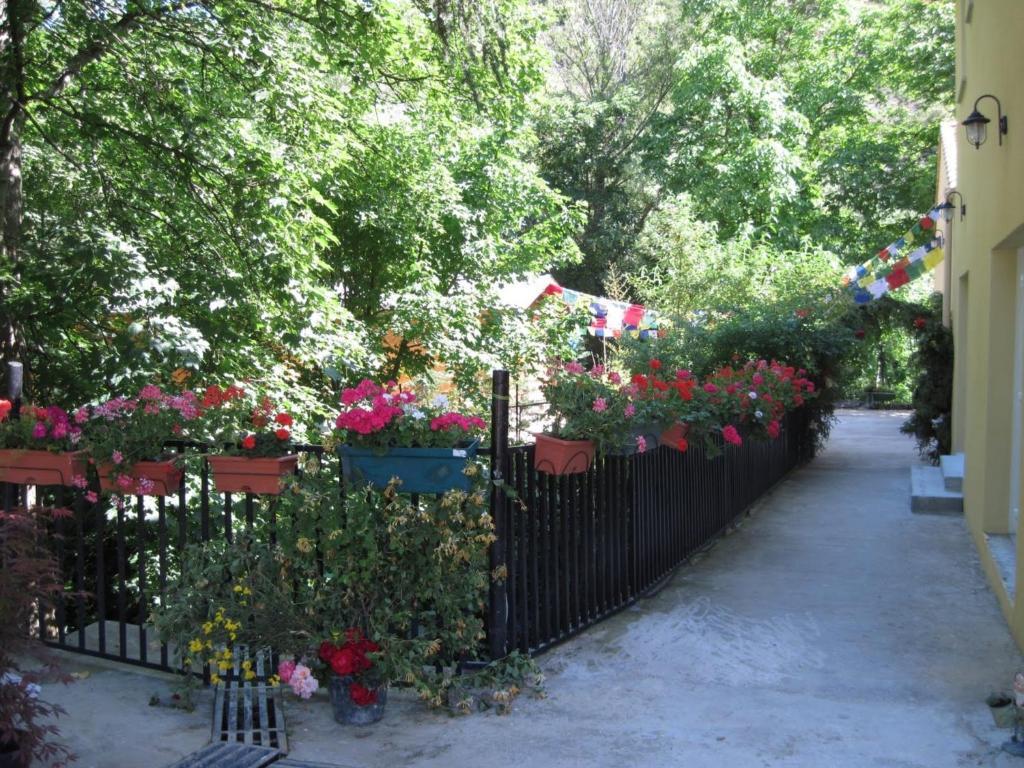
[487,371,509,658]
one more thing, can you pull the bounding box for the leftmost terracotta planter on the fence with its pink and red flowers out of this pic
[0,400,86,485]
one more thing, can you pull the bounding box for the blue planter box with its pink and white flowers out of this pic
[335,379,486,494]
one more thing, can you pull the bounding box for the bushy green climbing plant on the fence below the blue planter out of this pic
[156,454,494,707]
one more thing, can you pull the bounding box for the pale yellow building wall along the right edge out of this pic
[947,0,1024,647]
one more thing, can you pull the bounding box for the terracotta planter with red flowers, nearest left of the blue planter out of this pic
[197,385,298,496]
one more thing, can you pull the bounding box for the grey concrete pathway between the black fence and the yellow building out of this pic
[41,411,1024,768]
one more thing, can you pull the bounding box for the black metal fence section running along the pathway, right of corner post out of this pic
[488,399,813,655]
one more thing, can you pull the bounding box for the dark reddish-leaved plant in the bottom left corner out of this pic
[0,507,73,768]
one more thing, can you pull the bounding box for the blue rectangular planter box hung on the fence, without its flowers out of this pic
[338,440,480,494]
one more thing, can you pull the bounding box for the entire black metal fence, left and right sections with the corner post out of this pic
[0,372,812,671]
